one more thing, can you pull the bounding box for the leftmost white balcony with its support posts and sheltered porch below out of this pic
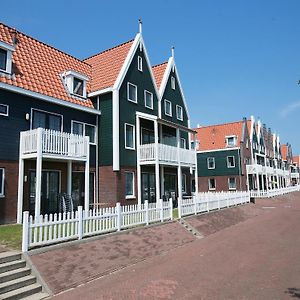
[17,128,90,223]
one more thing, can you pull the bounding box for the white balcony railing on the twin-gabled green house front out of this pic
[139,143,196,165]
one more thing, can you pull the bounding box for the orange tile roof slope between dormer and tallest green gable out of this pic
[84,40,133,92]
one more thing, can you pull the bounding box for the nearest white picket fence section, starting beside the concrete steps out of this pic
[22,199,173,252]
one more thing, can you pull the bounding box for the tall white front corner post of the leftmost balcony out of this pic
[35,128,43,218]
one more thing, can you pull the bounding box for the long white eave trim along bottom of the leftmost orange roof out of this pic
[0,82,101,115]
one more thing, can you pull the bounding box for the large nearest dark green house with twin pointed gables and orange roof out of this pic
[0,23,197,223]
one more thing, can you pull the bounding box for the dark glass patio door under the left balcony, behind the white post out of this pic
[29,170,60,215]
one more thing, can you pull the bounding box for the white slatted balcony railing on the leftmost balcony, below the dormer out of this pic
[20,128,89,158]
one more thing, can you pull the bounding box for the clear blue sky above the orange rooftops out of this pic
[0,0,300,154]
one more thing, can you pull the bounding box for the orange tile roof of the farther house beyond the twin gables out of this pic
[195,121,243,151]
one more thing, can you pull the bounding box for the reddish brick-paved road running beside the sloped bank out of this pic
[45,193,300,300]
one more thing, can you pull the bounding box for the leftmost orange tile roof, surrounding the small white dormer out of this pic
[0,23,93,108]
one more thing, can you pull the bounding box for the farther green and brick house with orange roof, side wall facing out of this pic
[195,119,251,192]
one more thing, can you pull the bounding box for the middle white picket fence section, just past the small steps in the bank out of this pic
[178,191,250,218]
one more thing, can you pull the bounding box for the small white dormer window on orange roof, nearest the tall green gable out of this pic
[63,71,88,98]
